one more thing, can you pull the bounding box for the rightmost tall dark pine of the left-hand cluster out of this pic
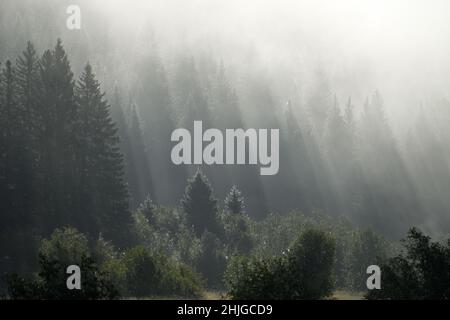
[76,64,131,245]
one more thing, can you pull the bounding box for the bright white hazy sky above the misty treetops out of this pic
[83,0,450,126]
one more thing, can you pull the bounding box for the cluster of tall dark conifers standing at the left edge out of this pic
[0,40,131,271]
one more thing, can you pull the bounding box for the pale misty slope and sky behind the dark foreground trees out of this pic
[0,0,450,238]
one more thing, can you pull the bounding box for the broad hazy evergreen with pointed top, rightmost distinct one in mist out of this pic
[358,92,420,235]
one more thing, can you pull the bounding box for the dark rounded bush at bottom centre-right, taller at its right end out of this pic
[225,230,334,300]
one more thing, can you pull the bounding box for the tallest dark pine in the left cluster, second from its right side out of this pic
[36,40,78,236]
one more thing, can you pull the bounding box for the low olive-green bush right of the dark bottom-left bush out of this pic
[123,246,202,298]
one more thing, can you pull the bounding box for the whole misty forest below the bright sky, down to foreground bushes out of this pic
[0,0,450,300]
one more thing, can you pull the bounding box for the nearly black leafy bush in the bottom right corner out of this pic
[366,228,450,300]
